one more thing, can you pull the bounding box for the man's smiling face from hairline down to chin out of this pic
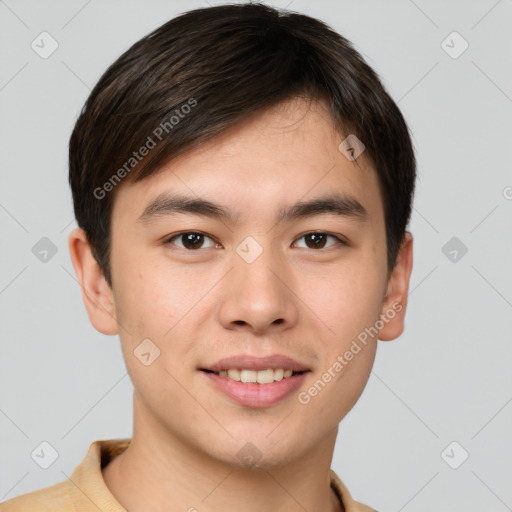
[71,99,410,467]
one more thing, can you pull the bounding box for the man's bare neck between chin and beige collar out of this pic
[102,395,343,512]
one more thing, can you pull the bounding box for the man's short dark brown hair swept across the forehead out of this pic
[69,3,416,286]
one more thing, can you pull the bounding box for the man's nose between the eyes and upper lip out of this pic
[217,242,298,334]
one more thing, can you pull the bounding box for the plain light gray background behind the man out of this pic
[0,0,512,512]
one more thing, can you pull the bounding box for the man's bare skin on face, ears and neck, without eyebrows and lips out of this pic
[69,98,412,512]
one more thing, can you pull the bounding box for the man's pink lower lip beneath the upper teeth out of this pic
[202,372,308,407]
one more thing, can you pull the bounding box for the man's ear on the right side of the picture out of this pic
[378,231,413,341]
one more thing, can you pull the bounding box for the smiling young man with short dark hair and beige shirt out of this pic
[0,4,415,512]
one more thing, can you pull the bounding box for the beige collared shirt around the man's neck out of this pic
[0,439,375,512]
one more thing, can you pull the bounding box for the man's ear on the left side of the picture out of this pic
[68,228,118,335]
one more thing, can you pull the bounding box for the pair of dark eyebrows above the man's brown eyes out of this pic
[137,192,368,224]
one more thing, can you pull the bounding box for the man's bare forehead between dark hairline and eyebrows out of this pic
[113,98,383,227]
